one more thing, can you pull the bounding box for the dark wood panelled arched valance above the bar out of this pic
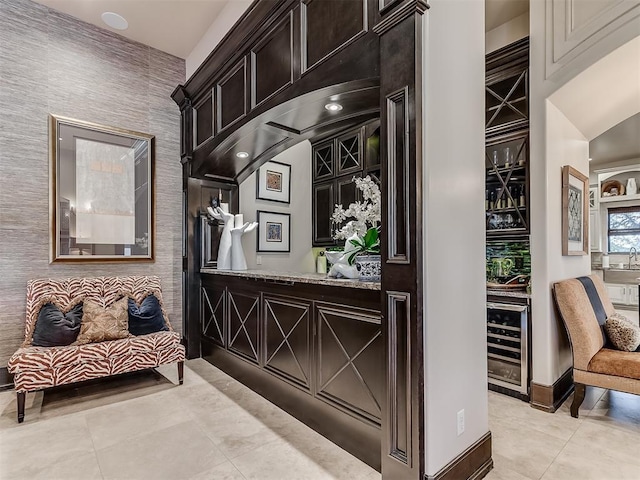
[173,0,380,183]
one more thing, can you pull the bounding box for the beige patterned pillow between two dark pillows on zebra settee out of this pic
[73,297,129,345]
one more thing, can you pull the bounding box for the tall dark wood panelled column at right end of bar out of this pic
[374,0,428,480]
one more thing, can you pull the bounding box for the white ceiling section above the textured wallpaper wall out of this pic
[31,0,233,58]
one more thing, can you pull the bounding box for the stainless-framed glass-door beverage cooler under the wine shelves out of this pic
[487,297,530,400]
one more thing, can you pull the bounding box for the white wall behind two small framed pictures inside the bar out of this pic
[240,140,315,273]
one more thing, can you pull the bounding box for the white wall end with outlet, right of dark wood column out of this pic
[423,0,489,475]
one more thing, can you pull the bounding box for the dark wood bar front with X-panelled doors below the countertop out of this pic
[200,274,385,468]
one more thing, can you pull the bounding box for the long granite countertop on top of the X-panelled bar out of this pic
[200,268,380,290]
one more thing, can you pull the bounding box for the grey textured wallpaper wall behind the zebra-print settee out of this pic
[0,0,185,367]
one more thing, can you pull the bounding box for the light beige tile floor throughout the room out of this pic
[0,359,640,480]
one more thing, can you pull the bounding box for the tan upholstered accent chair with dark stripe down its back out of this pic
[553,275,640,418]
